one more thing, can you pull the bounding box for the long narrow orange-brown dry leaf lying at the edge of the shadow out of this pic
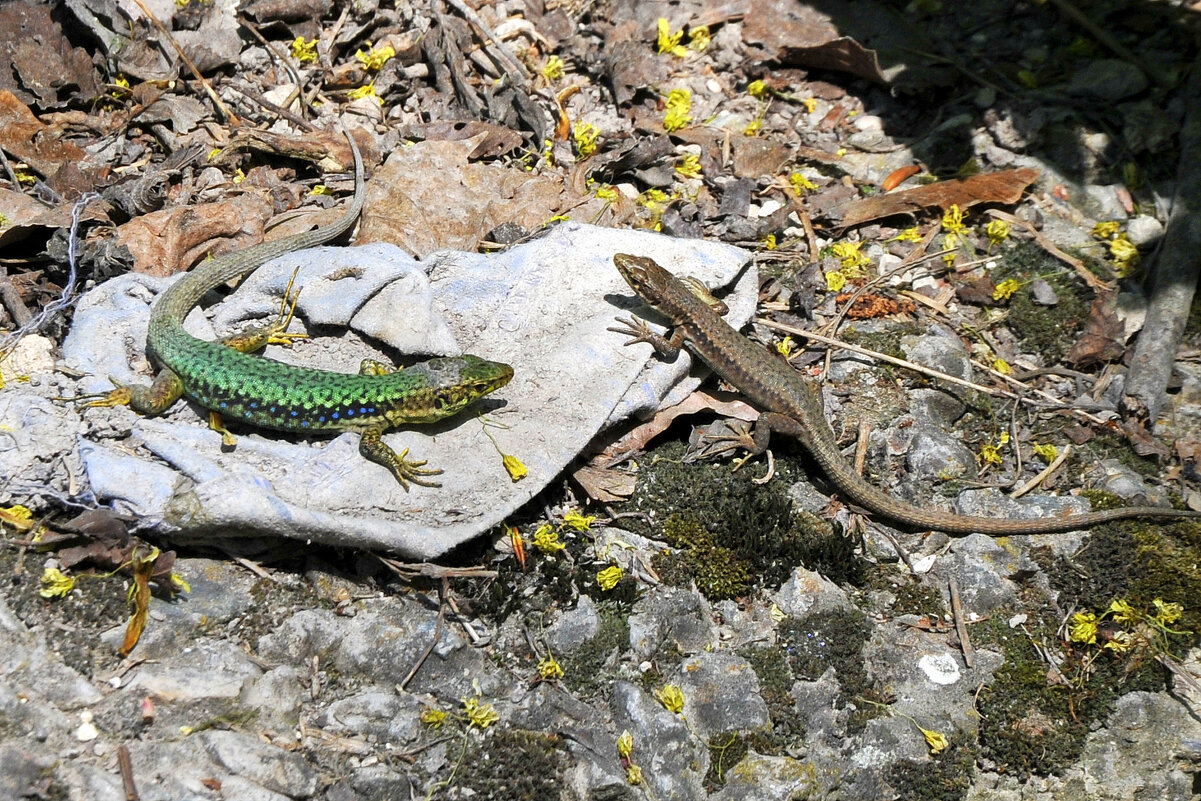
[842,167,1039,226]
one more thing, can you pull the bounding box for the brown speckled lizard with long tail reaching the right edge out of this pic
[610,253,1201,537]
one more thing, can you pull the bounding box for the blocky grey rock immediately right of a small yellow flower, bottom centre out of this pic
[675,651,770,740]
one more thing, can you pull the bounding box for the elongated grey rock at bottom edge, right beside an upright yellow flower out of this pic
[609,681,709,801]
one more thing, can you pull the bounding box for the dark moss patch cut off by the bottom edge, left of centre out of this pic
[454,729,570,801]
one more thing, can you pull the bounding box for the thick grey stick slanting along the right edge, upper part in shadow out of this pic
[1122,58,1201,422]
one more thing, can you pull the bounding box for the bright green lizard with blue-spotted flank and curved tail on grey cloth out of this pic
[88,131,513,490]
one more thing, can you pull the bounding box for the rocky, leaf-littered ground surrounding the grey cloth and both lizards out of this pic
[0,0,1201,801]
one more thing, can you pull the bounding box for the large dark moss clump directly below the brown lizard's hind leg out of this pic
[621,440,862,599]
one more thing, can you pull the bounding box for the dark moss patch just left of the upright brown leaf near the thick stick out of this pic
[993,241,1093,365]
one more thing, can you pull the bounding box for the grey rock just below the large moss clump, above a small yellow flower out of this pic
[629,585,717,659]
